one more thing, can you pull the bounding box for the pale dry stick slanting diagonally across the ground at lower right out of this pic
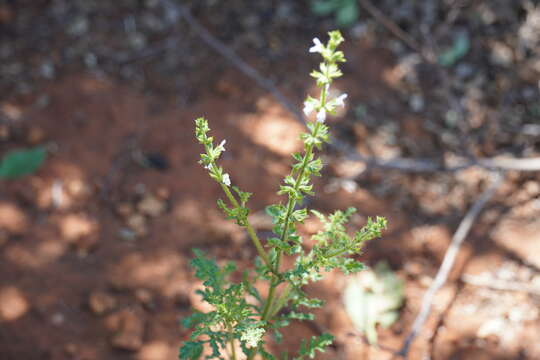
[398,173,503,358]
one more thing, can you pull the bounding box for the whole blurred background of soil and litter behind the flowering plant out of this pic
[0,0,540,360]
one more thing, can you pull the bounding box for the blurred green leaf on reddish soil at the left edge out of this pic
[0,146,47,179]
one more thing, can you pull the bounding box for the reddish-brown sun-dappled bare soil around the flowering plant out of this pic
[0,1,540,360]
